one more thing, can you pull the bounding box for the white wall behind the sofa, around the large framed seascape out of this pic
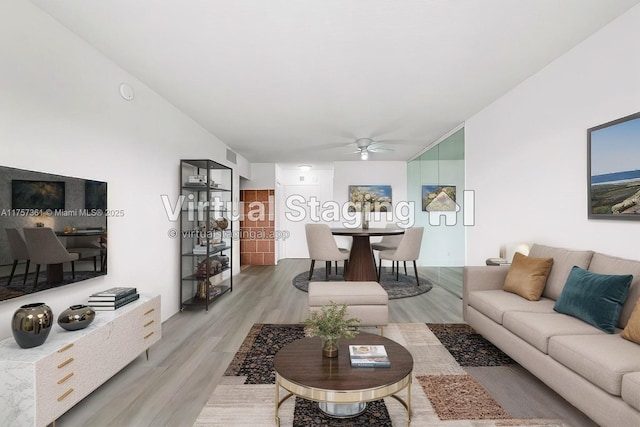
[465,6,640,265]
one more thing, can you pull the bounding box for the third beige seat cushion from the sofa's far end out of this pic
[549,334,640,396]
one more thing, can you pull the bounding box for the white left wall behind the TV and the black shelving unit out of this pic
[0,1,248,338]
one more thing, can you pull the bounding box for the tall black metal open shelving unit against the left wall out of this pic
[180,159,233,311]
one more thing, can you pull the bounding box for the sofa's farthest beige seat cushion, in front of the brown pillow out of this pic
[469,289,555,324]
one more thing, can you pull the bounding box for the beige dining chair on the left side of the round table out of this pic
[304,224,349,281]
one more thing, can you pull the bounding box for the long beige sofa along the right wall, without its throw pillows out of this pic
[463,244,640,427]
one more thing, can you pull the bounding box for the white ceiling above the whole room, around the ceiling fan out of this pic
[32,0,640,164]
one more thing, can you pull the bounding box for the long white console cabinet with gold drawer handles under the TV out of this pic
[0,296,162,427]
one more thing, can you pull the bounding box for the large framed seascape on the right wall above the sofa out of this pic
[587,113,640,220]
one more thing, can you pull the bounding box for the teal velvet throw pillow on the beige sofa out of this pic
[553,266,633,334]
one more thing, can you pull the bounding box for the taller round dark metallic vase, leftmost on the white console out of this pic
[11,302,53,348]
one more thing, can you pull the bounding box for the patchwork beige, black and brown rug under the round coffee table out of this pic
[194,323,565,427]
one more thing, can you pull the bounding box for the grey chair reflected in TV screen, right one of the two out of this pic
[23,227,79,290]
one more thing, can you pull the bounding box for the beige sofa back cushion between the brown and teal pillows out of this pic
[529,244,593,299]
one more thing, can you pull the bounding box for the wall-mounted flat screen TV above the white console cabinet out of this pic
[0,166,107,301]
